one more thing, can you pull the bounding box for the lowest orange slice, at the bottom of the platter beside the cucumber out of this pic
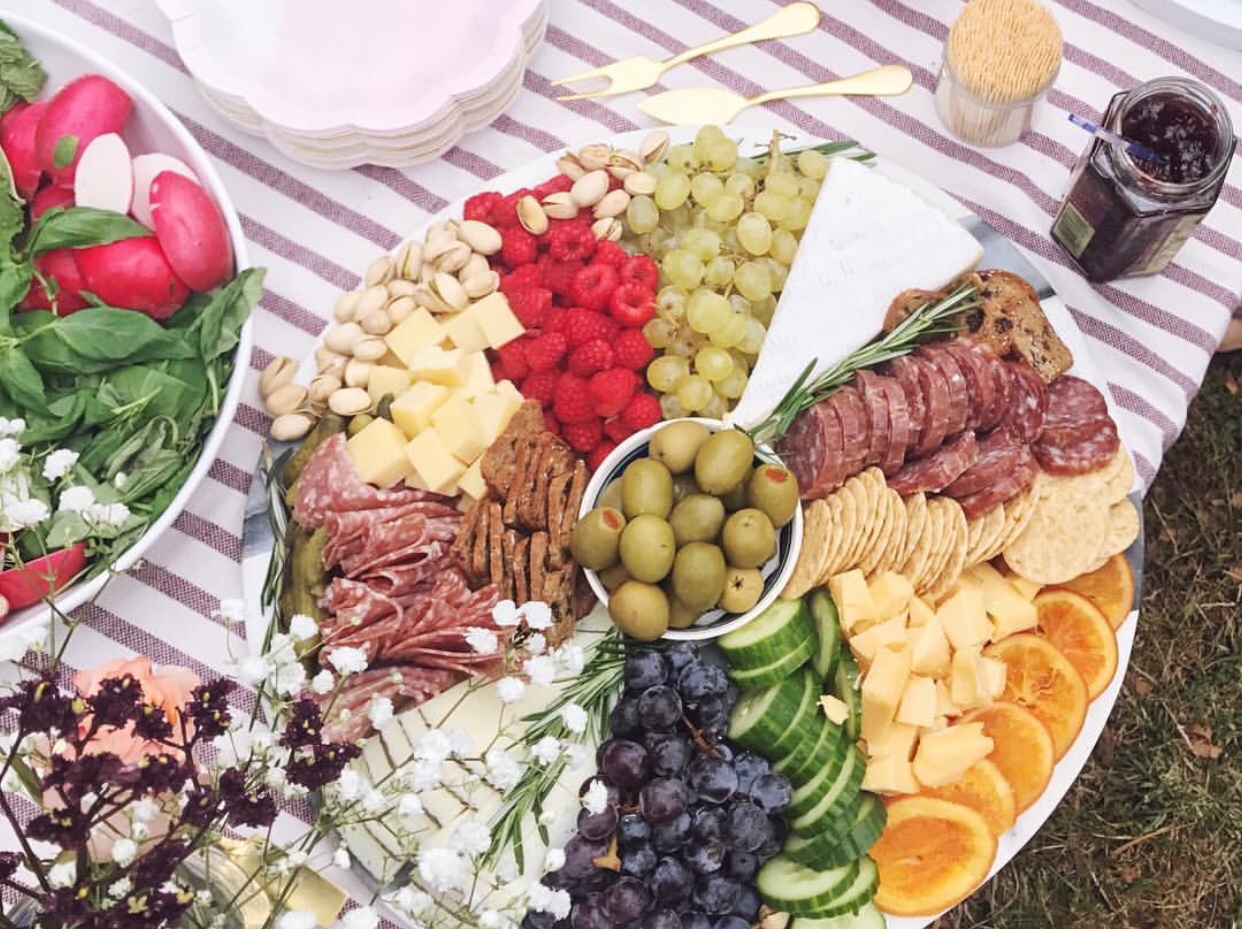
[871,796,996,917]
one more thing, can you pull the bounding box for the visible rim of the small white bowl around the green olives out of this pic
[578,416,802,640]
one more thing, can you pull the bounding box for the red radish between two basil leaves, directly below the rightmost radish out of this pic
[76,236,190,319]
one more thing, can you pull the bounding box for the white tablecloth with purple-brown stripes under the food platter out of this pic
[7,0,1242,919]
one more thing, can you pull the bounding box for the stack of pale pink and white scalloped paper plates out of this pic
[158,0,548,168]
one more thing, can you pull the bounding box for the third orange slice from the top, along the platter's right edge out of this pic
[984,632,1090,761]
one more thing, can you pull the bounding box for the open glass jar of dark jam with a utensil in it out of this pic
[1052,77,1236,282]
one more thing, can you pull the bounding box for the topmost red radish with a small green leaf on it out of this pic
[35,75,134,184]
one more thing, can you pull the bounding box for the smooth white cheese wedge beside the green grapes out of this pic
[729,158,984,426]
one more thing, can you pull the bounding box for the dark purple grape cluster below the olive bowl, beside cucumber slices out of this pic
[523,642,791,929]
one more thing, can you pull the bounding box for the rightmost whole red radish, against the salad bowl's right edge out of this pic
[150,171,232,291]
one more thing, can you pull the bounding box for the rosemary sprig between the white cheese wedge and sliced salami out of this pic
[746,284,979,445]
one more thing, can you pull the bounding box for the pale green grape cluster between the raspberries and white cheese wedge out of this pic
[625,125,828,419]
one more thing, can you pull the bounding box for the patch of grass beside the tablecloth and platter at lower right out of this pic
[936,351,1242,929]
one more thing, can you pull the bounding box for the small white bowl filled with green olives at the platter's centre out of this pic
[571,419,802,641]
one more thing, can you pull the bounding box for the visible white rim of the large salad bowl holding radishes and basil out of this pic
[0,12,253,630]
